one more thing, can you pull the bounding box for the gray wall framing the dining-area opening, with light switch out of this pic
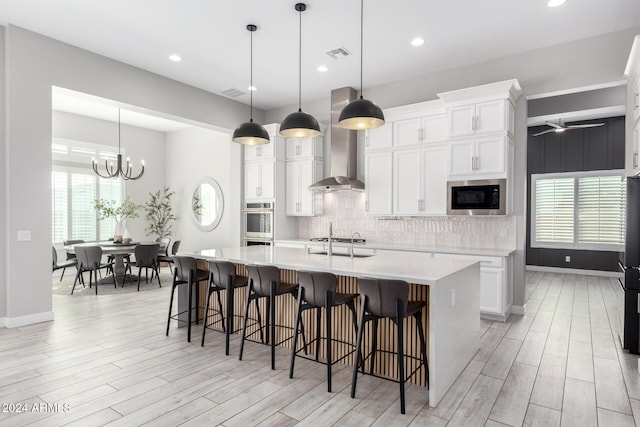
[2,25,263,326]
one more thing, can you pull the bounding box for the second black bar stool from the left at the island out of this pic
[200,261,249,356]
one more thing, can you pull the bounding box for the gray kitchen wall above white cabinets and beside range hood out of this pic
[265,27,640,314]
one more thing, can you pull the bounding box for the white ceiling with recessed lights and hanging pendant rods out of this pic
[0,0,640,129]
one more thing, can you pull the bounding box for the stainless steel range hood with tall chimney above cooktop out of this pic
[309,87,364,191]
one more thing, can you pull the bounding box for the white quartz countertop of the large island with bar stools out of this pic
[185,246,477,285]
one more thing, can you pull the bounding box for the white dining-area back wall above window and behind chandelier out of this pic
[52,111,165,241]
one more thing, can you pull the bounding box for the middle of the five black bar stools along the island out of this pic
[239,265,298,369]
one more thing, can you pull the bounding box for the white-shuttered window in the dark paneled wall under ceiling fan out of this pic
[531,170,626,251]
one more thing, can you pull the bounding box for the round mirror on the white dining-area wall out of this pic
[191,177,224,231]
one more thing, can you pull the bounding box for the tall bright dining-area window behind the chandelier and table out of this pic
[51,139,124,243]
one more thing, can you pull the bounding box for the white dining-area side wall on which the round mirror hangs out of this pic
[166,128,242,252]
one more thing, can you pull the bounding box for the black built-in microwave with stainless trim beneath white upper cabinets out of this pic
[447,179,507,215]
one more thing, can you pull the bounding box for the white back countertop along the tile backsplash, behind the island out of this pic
[276,239,515,257]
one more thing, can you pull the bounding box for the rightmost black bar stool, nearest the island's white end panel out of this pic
[351,278,430,414]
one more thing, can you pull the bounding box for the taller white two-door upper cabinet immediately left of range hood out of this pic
[286,159,322,216]
